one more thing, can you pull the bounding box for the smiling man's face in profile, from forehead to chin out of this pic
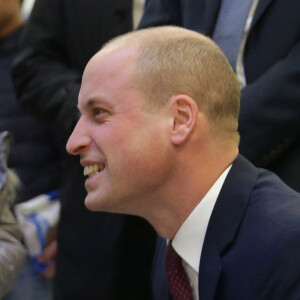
[67,48,173,215]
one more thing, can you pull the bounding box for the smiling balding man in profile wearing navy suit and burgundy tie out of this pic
[67,27,300,300]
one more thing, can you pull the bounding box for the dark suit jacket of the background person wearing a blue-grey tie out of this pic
[140,0,300,191]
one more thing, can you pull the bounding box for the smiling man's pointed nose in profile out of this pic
[66,116,91,155]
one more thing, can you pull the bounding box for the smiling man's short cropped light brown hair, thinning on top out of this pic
[102,26,240,141]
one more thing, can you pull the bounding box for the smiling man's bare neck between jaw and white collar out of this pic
[146,145,238,239]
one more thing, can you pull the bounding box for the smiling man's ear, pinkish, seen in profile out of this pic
[171,95,198,145]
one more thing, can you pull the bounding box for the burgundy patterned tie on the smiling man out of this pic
[166,241,193,300]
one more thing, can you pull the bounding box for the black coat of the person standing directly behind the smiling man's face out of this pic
[14,0,155,300]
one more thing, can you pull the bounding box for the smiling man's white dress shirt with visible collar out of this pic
[172,165,232,300]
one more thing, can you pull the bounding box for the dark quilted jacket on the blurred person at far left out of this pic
[0,28,63,202]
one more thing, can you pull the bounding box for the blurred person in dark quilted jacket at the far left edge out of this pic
[0,0,64,300]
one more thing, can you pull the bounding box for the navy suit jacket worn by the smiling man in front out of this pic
[153,156,300,300]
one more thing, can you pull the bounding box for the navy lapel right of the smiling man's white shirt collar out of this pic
[199,155,257,300]
